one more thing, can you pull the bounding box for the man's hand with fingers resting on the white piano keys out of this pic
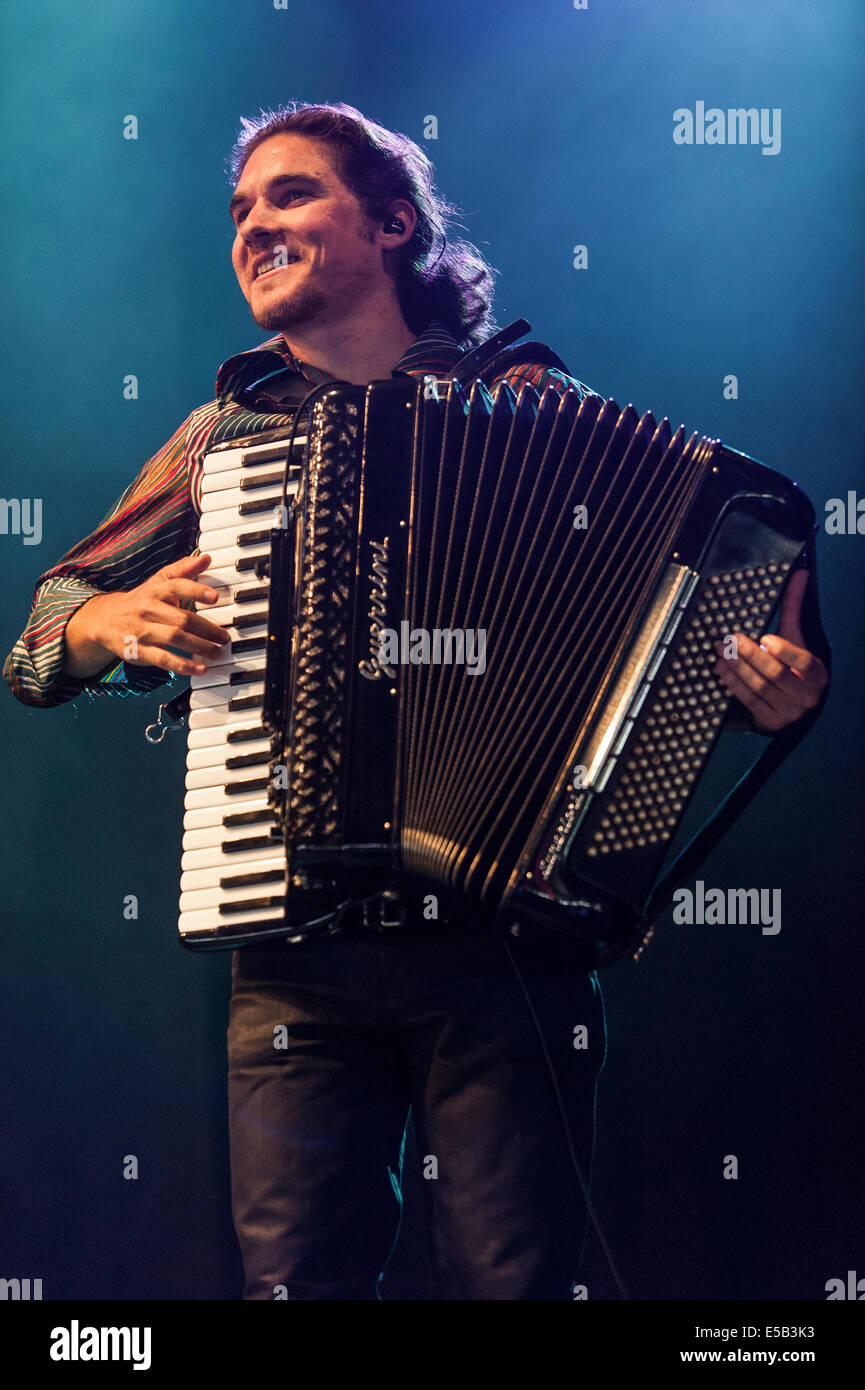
[63,555,228,680]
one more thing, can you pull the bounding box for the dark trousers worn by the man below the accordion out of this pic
[228,922,606,1300]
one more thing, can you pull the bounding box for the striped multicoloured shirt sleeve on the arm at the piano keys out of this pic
[3,416,197,708]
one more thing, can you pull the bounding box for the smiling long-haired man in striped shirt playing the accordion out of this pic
[6,106,826,1300]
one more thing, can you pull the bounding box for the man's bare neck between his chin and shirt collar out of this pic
[282,290,417,386]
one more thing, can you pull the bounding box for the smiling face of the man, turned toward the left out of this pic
[231,133,385,331]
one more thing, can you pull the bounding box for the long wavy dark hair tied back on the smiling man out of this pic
[229,101,496,348]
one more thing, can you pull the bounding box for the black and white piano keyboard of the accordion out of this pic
[178,438,305,944]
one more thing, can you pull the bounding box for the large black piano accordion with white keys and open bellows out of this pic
[179,378,814,949]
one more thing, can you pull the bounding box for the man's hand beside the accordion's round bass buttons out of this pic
[715,570,829,734]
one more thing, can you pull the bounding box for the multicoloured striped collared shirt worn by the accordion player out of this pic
[3,320,595,708]
